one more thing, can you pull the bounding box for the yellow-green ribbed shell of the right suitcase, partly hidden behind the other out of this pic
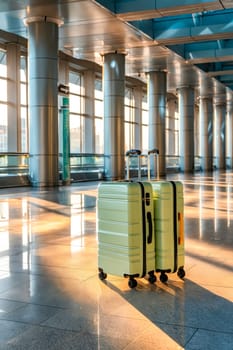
[151,181,184,272]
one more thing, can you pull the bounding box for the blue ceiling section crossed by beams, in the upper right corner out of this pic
[93,0,233,88]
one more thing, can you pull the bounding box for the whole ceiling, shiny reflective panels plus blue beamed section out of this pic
[0,0,233,99]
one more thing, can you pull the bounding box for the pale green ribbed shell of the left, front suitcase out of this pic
[97,182,155,277]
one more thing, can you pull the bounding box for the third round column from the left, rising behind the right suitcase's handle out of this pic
[148,71,167,177]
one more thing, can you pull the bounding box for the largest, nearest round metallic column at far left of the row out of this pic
[26,16,60,187]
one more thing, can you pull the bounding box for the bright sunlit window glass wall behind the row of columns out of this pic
[0,39,182,178]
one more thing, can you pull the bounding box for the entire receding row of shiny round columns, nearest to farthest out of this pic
[23,16,233,186]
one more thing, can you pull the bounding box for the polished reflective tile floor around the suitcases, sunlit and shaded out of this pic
[0,172,233,350]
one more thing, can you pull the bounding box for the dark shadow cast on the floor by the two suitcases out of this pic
[101,279,233,350]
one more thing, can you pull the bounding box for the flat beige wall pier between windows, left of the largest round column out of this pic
[7,43,21,152]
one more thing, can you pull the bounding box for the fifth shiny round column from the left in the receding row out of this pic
[199,96,213,171]
